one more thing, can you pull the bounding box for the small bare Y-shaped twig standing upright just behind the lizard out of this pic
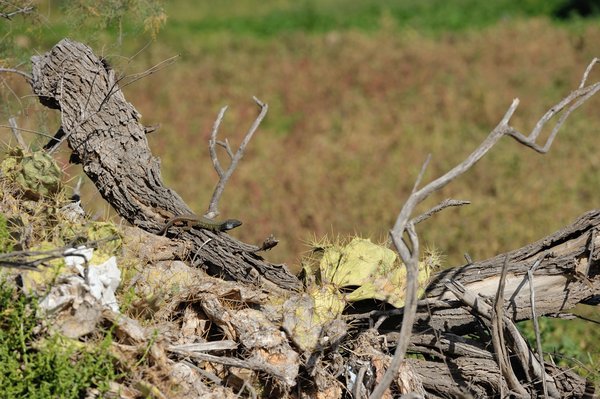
[205,97,269,218]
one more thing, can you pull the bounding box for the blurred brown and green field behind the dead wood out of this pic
[0,0,600,382]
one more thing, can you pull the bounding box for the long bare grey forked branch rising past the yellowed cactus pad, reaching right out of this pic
[370,58,600,399]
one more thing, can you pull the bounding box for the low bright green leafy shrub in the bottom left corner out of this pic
[0,281,116,399]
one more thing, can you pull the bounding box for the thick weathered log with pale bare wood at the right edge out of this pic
[426,210,600,321]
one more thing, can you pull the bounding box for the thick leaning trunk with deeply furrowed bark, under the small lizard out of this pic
[31,39,299,289]
